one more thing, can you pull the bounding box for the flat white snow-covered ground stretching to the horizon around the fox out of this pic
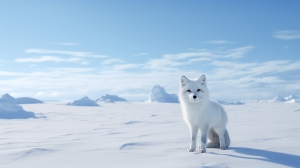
[0,102,300,168]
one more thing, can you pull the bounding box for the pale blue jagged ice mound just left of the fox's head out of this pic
[147,85,179,103]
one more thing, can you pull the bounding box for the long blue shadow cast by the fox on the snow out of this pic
[213,147,300,167]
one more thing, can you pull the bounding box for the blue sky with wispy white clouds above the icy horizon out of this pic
[0,0,300,101]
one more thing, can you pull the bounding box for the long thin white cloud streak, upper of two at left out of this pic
[25,49,108,58]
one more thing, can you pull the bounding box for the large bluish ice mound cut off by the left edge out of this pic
[0,94,36,119]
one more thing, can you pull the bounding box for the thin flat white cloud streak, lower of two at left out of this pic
[15,56,81,63]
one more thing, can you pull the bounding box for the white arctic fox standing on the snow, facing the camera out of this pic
[179,75,230,153]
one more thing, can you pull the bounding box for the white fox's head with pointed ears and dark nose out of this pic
[179,75,208,103]
